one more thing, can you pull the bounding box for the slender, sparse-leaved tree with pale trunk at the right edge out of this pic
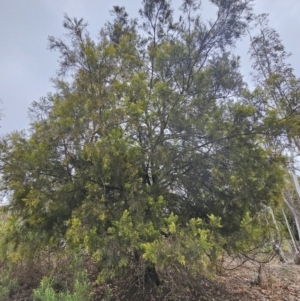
[250,15,300,258]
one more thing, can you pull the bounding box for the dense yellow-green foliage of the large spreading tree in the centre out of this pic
[1,0,299,296]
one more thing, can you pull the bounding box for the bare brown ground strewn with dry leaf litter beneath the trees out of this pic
[7,254,300,301]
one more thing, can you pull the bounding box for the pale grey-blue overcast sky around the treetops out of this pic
[0,0,300,135]
